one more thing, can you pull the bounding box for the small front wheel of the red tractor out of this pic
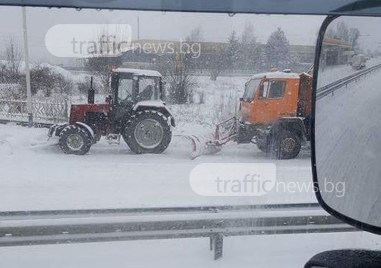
[58,125,93,155]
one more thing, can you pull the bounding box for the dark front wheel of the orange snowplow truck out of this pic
[269,130,302,159]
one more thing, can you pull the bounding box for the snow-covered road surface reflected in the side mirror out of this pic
[316,66,381,225]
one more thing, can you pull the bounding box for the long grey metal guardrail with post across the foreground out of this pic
[0,204,356,259]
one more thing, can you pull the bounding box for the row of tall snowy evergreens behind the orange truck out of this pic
[183,24,295,80]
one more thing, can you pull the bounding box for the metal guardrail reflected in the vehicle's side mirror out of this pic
[316,64,381,100]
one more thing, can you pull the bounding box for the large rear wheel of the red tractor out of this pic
[122,110,172,154]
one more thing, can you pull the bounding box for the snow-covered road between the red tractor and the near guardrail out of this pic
[0,124,316,211]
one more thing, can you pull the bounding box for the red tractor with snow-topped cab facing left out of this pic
[48,68,175,155]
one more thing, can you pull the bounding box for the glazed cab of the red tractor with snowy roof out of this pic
[111,68,163,106]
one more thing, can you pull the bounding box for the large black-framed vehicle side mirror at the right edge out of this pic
[311,17,381,233]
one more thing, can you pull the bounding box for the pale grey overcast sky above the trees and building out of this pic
[0,7,378,62]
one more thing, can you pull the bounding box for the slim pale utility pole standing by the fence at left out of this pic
[22,6,33,127]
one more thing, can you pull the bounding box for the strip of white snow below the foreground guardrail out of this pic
[0,232,380,268]
